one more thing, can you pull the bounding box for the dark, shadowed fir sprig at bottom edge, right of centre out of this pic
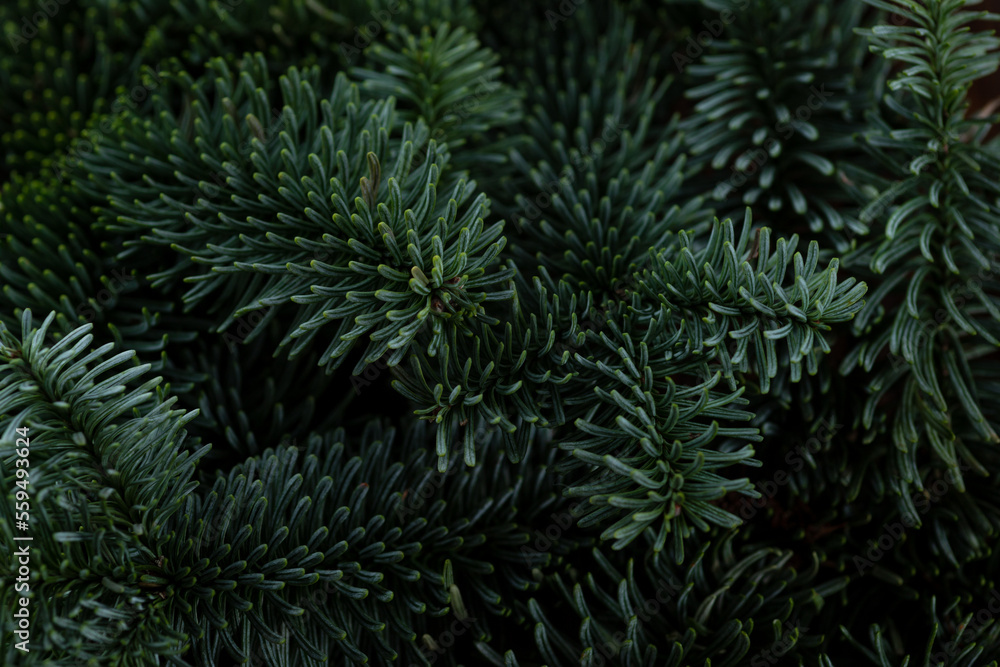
[479,532,847,667]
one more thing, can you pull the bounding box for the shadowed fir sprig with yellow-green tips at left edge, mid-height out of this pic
[0,174,207,380]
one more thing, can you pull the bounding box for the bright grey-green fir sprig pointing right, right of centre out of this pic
[638,208,867,392]
